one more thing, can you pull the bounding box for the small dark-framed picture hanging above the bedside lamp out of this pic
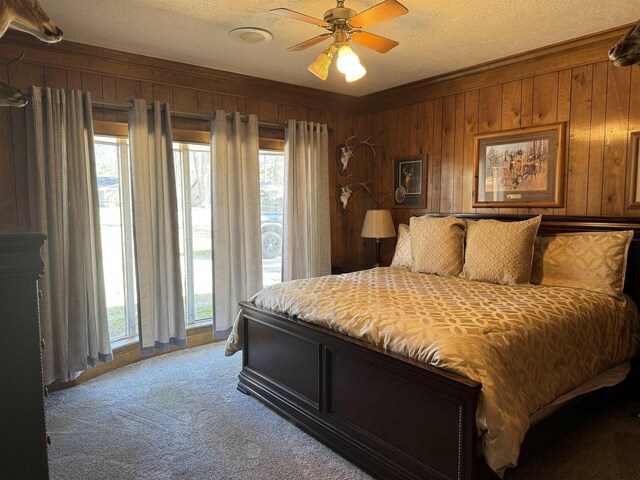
[393,155,426,208]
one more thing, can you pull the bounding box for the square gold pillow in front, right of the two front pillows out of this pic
[461,215,542,285]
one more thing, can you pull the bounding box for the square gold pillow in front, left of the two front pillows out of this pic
[409,217,464,277]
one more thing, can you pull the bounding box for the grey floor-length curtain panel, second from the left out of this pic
[129,100,187,355]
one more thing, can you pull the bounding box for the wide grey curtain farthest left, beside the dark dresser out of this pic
[27,87,112,384]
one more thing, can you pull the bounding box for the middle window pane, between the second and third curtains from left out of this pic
[173,143,213,325]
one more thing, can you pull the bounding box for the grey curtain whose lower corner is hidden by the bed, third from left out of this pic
[211,110,262,337]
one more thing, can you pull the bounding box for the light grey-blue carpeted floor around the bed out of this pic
[47,344,640,480]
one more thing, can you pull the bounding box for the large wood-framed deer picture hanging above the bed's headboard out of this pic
[473,123,565,207]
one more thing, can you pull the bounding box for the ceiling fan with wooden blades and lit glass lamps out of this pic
[271,0,409,82]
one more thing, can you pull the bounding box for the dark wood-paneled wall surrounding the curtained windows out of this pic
[0,32,366,262]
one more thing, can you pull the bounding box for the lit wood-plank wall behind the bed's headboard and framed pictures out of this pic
[353,26,640,262]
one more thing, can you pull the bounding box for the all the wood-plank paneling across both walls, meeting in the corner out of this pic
[0,26,640,264]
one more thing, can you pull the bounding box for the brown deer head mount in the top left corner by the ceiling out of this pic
[0,0,62,43]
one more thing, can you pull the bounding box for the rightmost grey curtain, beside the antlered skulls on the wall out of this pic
[282,120,331,281]
